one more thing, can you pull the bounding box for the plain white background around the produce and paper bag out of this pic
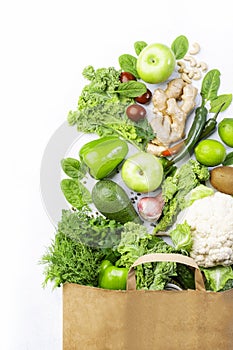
[0,0,233,350]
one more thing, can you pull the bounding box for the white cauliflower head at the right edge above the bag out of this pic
[182,192,233,267]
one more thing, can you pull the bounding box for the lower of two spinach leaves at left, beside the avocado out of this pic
[61,179,92,209]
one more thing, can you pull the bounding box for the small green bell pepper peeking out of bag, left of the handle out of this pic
[99,260,128,290]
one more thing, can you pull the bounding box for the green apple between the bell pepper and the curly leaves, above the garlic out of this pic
[121,152,163,193]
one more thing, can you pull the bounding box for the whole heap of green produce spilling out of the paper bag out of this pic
[42,35,233,291]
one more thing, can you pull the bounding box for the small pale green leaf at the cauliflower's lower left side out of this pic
[170,221,193,252]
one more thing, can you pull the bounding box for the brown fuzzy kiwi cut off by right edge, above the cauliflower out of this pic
[210,166,233,195]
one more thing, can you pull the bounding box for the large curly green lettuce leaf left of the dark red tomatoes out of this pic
[68,66,154,150]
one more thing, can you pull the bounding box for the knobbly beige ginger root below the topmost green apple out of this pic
[147,78,197,156]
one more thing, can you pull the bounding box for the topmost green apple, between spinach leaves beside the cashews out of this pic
[137,43,176,84]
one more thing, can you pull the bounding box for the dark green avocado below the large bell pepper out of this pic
[92,179,141,224]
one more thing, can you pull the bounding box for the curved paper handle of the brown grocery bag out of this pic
[127,253,206,291]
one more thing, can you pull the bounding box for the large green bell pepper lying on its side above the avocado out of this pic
[79,136,128,180]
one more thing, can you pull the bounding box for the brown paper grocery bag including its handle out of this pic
[63,254,233,350]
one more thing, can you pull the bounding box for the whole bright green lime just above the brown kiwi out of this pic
[194,140,226,166]
